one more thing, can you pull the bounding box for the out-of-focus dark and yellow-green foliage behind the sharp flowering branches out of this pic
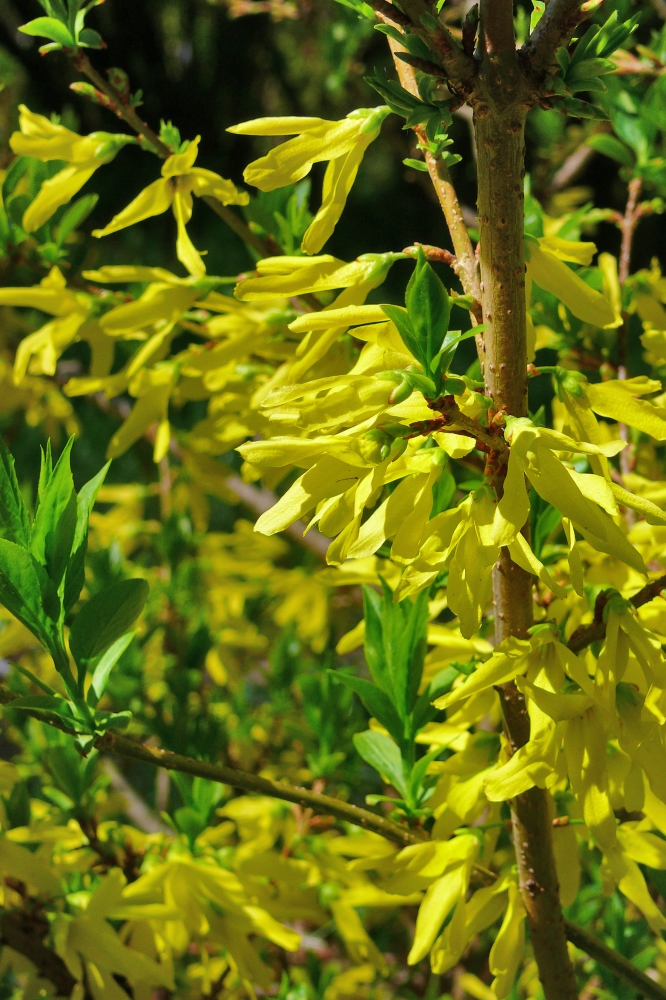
[0,0,666,1000]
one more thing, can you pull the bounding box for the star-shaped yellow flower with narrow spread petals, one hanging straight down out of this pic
[93,136,249,277]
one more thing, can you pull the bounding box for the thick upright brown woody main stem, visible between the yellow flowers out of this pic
[474,0,578,1000]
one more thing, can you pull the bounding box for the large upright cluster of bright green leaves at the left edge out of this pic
[0,439,148,733]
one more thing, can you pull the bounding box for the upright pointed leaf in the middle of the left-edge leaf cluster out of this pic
[30,438,76,587]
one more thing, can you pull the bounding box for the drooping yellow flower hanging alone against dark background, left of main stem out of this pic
[227,105,391,254]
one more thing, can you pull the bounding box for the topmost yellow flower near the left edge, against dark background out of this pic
[9,104,136,233]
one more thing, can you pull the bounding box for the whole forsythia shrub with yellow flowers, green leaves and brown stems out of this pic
[0,0,666,1000]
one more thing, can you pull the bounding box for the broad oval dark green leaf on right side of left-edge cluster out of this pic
[69,580,149,669]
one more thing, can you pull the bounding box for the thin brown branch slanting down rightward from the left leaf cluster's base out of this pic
[95,732,427,847]
